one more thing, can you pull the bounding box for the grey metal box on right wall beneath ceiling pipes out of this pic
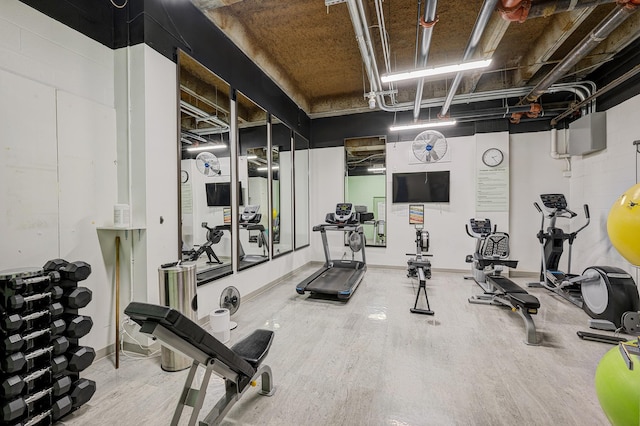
[569,112,607,155]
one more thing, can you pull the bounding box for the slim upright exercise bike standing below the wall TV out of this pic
[407,209,434,315]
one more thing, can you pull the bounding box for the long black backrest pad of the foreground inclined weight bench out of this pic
[124,302,256,378]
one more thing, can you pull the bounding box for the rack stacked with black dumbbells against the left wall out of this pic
[0,259,96,426]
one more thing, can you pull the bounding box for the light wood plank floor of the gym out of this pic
[63,268,610,426]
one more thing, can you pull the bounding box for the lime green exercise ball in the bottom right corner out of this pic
[595,346,640,426]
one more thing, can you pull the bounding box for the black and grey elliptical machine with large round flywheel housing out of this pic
[529,194,640,331]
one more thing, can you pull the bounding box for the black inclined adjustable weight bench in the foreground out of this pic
[124,302,275,426]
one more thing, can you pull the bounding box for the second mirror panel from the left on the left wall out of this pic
[236,92,271,270]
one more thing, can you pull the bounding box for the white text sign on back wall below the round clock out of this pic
[476,167,509,212]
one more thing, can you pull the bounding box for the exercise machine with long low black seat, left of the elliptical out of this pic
[465,219,540,345]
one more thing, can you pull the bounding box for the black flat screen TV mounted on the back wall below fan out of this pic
[393,170,449,203]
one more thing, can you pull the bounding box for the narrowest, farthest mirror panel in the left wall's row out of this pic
[293,133,309,249]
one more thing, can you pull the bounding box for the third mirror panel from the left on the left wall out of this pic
[271,117,293,257]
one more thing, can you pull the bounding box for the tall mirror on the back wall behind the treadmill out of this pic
[344,136,387,247]
